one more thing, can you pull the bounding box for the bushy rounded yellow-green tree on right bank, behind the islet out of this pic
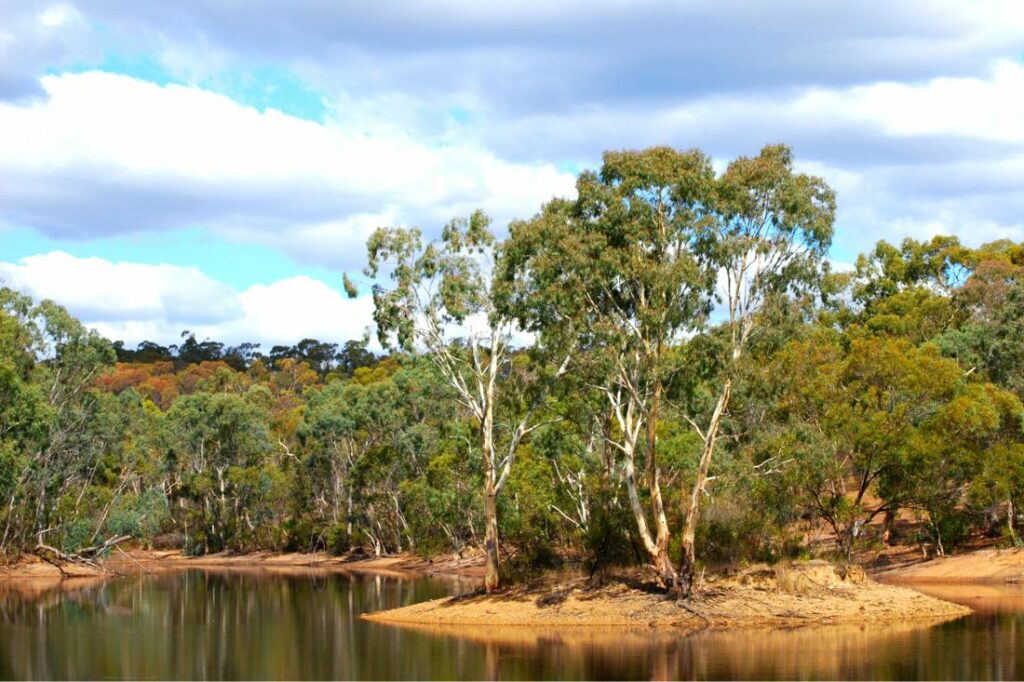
[759,333,1022,560]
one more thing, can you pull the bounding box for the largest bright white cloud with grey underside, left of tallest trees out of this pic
[0,72,573,266]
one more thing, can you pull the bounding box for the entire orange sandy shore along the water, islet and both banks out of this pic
[6,548,1024,631]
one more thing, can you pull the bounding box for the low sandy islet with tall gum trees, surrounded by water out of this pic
[361,561,971,630]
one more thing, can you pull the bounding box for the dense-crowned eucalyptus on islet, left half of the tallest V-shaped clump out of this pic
[504,147,715,586]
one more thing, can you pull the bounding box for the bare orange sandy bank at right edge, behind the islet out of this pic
[873,549,1024,583]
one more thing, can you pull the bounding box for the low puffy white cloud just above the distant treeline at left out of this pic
[0,251,373,347]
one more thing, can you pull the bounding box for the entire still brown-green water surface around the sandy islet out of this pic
[0,570,1024,680]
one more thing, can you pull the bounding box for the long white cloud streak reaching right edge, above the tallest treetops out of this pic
[486,59,1024,156]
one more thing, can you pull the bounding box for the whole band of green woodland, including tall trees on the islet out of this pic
[0,145,1024,595]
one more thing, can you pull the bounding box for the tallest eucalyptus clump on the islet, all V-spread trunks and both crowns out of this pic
[504,145,835,597]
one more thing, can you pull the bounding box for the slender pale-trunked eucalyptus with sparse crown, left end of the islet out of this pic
[360,211,568,592]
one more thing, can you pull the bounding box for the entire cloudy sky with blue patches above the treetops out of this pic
[0,0,1024,348]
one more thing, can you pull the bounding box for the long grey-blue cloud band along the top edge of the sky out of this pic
[64,0,1024,111]
